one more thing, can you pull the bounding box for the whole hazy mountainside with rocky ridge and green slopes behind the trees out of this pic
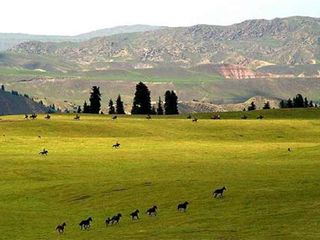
[0,17,320,112]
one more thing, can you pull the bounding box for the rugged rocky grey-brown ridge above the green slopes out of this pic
[10,17,320,67]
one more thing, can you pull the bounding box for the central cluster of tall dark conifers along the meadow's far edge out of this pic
[77,82,179,115]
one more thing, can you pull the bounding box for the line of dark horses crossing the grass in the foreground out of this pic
[56,187,226,234]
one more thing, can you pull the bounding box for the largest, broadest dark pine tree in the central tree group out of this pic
[131,82,151,114]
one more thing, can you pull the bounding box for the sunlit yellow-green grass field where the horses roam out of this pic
[0,110,320,240]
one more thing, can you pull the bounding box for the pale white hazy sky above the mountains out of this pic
[0,0,320,35]
